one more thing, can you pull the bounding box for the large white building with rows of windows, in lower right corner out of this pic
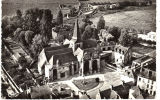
[137,59,156,96]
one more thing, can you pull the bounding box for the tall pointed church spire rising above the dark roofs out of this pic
[72,19,81,42]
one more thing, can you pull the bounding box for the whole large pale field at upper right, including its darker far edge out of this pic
[91,5,156,31]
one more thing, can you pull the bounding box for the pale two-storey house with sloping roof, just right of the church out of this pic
[114,45,132,67]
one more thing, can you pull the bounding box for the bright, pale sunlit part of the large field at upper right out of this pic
[91,10,156,31]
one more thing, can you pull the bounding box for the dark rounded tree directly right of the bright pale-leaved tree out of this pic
[108,26,121,42]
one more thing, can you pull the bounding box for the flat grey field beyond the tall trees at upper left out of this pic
[2,0,78,18]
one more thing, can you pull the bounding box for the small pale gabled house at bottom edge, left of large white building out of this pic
[128,86,144,99]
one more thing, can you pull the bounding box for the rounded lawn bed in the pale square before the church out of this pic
[73,78,99,91]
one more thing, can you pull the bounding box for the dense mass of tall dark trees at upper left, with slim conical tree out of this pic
[2,8,63,58]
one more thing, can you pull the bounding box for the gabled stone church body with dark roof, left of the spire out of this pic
[38,45,79,81]
